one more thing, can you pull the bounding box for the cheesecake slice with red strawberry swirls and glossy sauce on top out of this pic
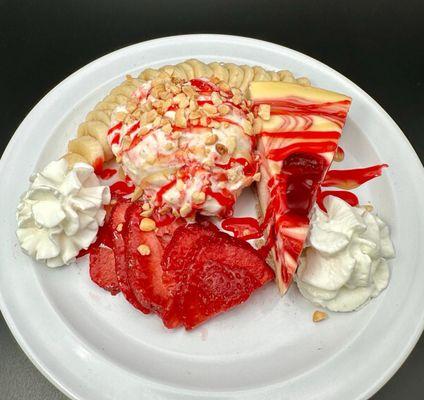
[250,82,351,294]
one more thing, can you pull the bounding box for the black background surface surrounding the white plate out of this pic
[0,0,424,400]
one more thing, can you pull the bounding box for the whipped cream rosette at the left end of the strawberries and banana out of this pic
[16,159,110,267]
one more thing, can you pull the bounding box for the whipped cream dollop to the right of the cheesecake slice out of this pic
[295,196,395,312]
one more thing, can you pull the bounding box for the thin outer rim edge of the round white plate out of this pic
[0,34,424,400]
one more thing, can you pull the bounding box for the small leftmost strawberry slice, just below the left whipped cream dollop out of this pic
[90,247,120,295]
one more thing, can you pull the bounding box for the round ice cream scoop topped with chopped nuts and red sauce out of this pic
[108,77,259,217]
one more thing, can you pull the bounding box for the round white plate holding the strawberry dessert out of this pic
[0,35,424,400]
